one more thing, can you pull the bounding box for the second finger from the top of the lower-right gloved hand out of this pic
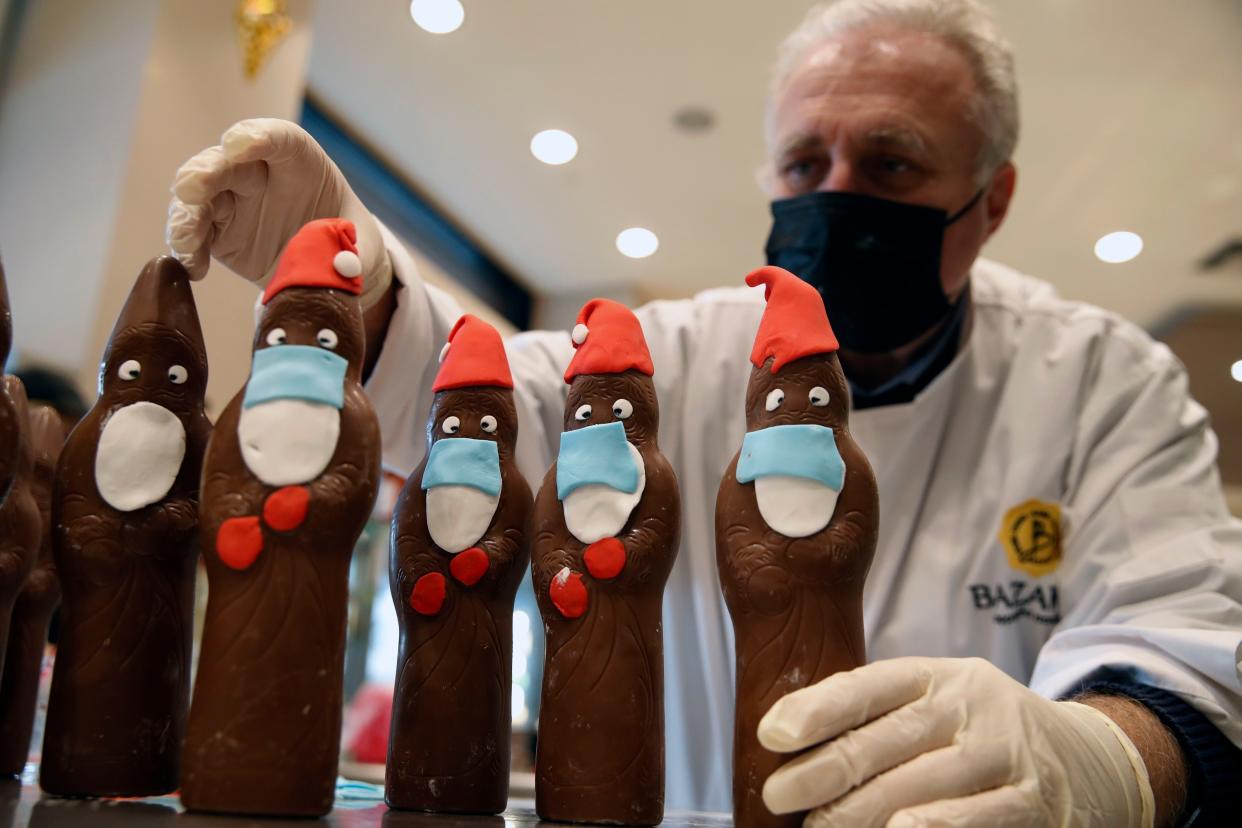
[764,701,961,813]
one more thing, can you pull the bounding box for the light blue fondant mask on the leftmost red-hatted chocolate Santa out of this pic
[241,345,349,408]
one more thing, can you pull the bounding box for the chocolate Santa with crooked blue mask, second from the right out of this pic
[532,299,681,826]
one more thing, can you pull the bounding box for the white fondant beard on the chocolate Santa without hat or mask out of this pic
[94,402,185,511]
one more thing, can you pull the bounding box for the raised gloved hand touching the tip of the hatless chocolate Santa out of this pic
[166,118,392,308]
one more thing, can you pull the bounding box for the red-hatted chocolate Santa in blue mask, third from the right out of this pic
[385,314,532,813]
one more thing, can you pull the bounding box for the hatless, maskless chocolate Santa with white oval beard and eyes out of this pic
[40,256,211,796]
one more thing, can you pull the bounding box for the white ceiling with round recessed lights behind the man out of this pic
[309,0,1242,324]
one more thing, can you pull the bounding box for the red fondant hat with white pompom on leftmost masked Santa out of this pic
[263,218,363,304]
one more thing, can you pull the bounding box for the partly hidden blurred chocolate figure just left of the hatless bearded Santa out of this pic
[0,403,65,776]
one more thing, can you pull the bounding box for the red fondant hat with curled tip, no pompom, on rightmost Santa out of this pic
[746,264,838,374]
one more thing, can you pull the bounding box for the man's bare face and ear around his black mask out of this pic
[771,29,1015,298]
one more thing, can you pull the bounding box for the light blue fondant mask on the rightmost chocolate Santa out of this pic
[737,423,846,492]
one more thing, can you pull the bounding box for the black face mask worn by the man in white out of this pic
[765,190,984,354]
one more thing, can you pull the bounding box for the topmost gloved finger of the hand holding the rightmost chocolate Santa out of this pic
[759,658,932,754]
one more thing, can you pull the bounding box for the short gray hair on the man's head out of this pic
[768,0,1017,182]
